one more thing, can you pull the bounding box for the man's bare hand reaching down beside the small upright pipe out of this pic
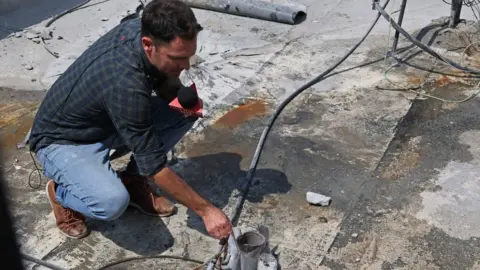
[202,207,232,240]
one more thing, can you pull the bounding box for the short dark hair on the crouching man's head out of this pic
[142,0,203,44]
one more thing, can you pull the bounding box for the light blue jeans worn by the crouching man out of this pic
[36,97,196,220]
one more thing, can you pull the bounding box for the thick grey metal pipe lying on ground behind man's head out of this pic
[182,0,307,24]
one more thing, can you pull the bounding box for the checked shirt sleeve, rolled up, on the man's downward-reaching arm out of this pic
[105,77,167,176]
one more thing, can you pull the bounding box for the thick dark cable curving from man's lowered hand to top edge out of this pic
[207,0,390,270]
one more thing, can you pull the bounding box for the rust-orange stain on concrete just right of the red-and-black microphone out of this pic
[213,100,268,128]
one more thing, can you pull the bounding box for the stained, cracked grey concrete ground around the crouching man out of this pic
[0,0,480,270]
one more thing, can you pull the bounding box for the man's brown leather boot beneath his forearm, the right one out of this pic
[119,172,177,217]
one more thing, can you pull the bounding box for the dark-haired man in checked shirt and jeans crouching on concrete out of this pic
[29,0,232,239]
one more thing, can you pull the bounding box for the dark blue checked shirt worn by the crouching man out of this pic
[29,18,172,175]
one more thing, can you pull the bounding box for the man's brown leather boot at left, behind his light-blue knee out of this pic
[46,180,90,239]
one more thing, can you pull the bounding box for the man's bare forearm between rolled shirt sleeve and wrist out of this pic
[148,167,214,217]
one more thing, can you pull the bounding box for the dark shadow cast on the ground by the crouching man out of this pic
[91,153,291,256]
